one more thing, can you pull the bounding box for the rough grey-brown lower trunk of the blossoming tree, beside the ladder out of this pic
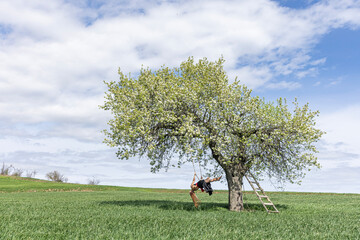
[226,172,244,212]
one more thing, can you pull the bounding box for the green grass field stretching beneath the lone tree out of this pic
[0,176,360,240]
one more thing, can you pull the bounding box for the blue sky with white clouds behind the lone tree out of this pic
[0,0,360,193]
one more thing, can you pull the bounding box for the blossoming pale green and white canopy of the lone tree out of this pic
[102,57,323,211]
